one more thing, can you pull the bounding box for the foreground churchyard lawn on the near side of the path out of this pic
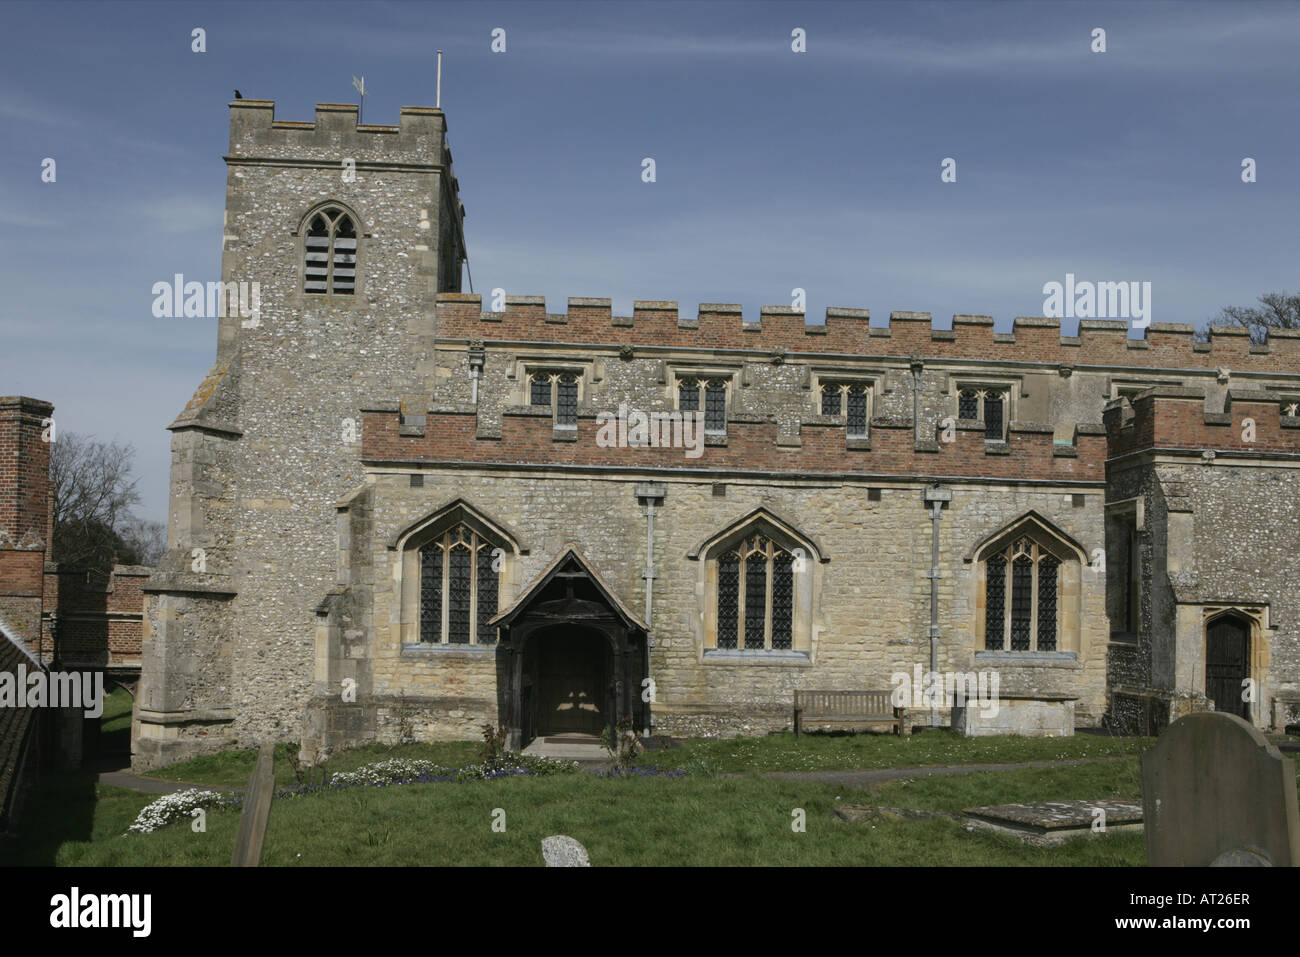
[12,762,1145,866]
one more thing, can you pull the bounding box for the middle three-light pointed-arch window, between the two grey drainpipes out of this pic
[718,534,794,650]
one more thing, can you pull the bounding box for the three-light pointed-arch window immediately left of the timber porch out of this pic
[420,524,501,645]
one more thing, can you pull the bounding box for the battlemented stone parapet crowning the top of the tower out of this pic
[226,100,451,174]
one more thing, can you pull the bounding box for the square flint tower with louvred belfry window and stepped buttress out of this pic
[135,100,465,766]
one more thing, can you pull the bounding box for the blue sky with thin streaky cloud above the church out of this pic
[0,0,1300,520]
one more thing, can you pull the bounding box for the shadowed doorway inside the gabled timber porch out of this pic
[529,628,610,736]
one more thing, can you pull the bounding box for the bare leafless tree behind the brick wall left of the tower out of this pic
[49,432,140,570]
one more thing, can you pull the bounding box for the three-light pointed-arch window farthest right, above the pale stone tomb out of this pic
[984,537,1061,651]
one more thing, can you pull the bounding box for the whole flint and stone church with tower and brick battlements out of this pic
[134,99,1300,768]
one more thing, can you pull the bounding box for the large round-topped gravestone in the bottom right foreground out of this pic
[1141,711,1300,867]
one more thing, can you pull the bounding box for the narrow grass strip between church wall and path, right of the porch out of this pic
[640,729,1156,774]
